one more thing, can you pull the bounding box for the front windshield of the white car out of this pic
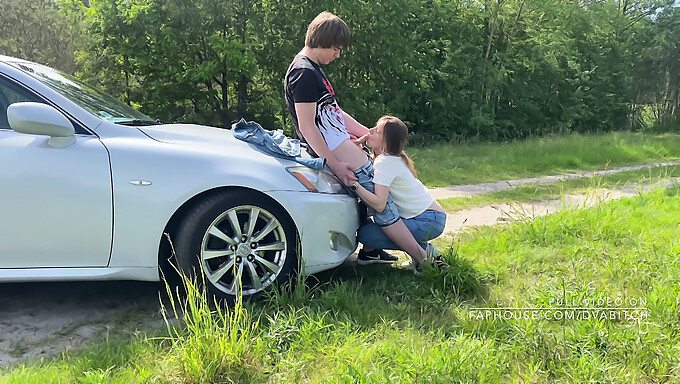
[11,62,153,123]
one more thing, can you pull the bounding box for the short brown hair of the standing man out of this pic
[305,11,350,49]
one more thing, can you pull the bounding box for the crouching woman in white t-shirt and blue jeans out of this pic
[352,116,448,271]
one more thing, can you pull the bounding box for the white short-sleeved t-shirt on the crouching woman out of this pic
[373,155,434,219]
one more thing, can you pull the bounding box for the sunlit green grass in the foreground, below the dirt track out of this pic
[5,186,680,383]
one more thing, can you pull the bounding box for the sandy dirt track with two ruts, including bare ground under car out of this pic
[0,161,680,367]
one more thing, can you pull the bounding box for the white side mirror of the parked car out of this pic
[7,102,76,148]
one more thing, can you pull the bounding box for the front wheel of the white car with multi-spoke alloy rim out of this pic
[174,190,298,302]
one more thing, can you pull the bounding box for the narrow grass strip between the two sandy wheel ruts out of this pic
[439,161,680,212]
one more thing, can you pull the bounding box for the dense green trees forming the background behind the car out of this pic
[0,0,680,142]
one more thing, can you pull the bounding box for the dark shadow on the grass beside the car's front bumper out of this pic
[260,246,490,329]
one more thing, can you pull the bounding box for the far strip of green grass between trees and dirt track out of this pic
[407,132,680,187]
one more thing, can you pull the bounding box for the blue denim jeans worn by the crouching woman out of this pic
[357,210,446,250]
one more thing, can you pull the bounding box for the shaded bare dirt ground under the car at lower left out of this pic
[0,281,165,367]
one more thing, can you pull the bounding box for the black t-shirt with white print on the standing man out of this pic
[284,55,349,156]
